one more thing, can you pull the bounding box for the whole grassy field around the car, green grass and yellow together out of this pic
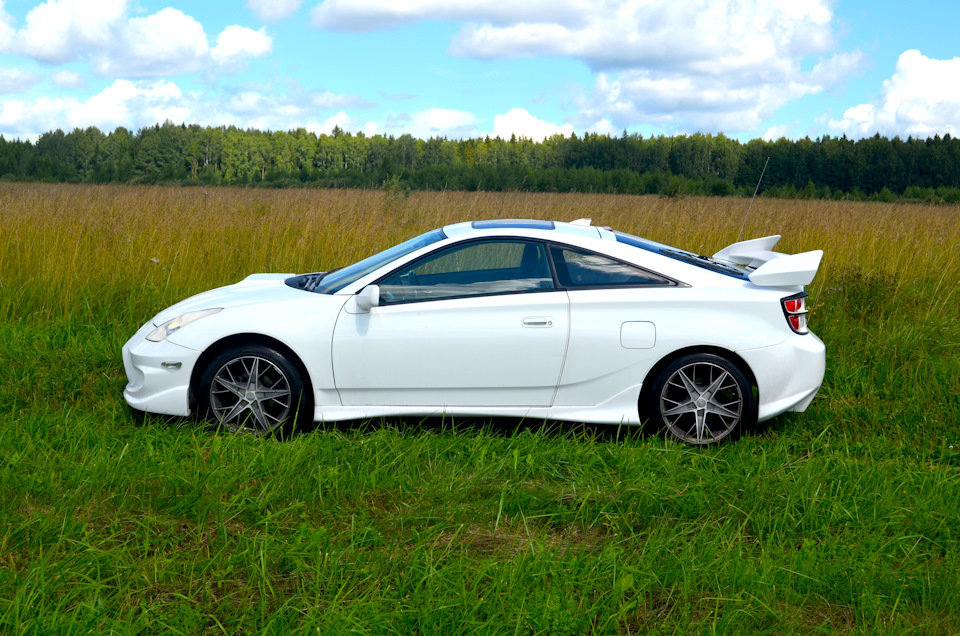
[0,184,960,634]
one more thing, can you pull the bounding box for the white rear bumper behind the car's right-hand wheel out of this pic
[737,333,827,422]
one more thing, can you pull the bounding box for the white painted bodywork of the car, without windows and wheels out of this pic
[123,217,825,432]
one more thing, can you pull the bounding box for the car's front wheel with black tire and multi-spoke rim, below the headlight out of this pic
[197,345,313,436]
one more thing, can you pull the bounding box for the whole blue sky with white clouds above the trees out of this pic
[0,0,960,140]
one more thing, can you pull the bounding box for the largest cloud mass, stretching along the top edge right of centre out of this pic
[312,0,864,131]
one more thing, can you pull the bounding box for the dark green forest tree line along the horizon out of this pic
[0,121,960,203]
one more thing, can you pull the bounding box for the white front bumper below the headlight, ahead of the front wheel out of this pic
[123,323,200,416]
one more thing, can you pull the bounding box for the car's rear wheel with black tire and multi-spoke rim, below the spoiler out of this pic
[645,353,757,446]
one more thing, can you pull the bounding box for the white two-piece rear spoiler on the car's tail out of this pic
[713,234,823,287]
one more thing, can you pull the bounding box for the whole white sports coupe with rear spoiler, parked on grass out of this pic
[123,219,825,444]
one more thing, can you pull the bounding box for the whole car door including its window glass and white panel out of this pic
[333,238,569,407]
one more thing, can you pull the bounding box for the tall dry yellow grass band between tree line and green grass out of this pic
[0,184,960,316]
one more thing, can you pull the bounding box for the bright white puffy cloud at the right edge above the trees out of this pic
[828,50,960,137]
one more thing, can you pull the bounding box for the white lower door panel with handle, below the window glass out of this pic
[333,291,569,407]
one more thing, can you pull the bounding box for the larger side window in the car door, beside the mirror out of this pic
[379,240,553,305]
